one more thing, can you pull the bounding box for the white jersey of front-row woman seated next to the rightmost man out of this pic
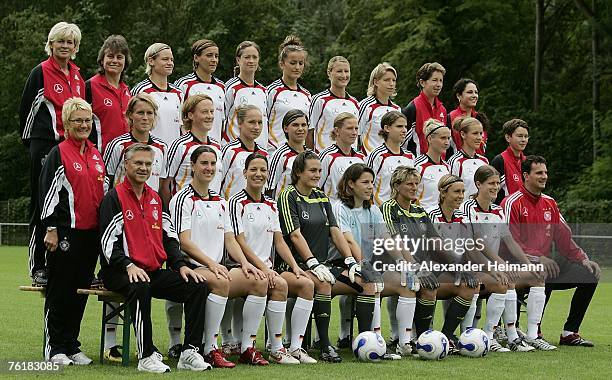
[461,198,511,253]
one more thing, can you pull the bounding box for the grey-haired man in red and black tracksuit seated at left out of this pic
[100,144,211,373]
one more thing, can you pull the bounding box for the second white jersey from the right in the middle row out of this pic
[414,154,450,212]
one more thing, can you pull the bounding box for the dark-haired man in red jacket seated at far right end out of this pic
[501,156,600,347]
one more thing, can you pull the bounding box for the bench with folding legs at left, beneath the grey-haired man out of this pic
[19,285,132,366]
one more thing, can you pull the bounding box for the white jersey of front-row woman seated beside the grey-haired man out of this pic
[170,185,233,265]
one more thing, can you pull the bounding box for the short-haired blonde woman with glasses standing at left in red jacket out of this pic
[39,98,106,365]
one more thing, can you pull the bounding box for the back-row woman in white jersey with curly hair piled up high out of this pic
[266,35,310,154]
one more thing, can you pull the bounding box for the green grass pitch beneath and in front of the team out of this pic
[0,247,612,380]
